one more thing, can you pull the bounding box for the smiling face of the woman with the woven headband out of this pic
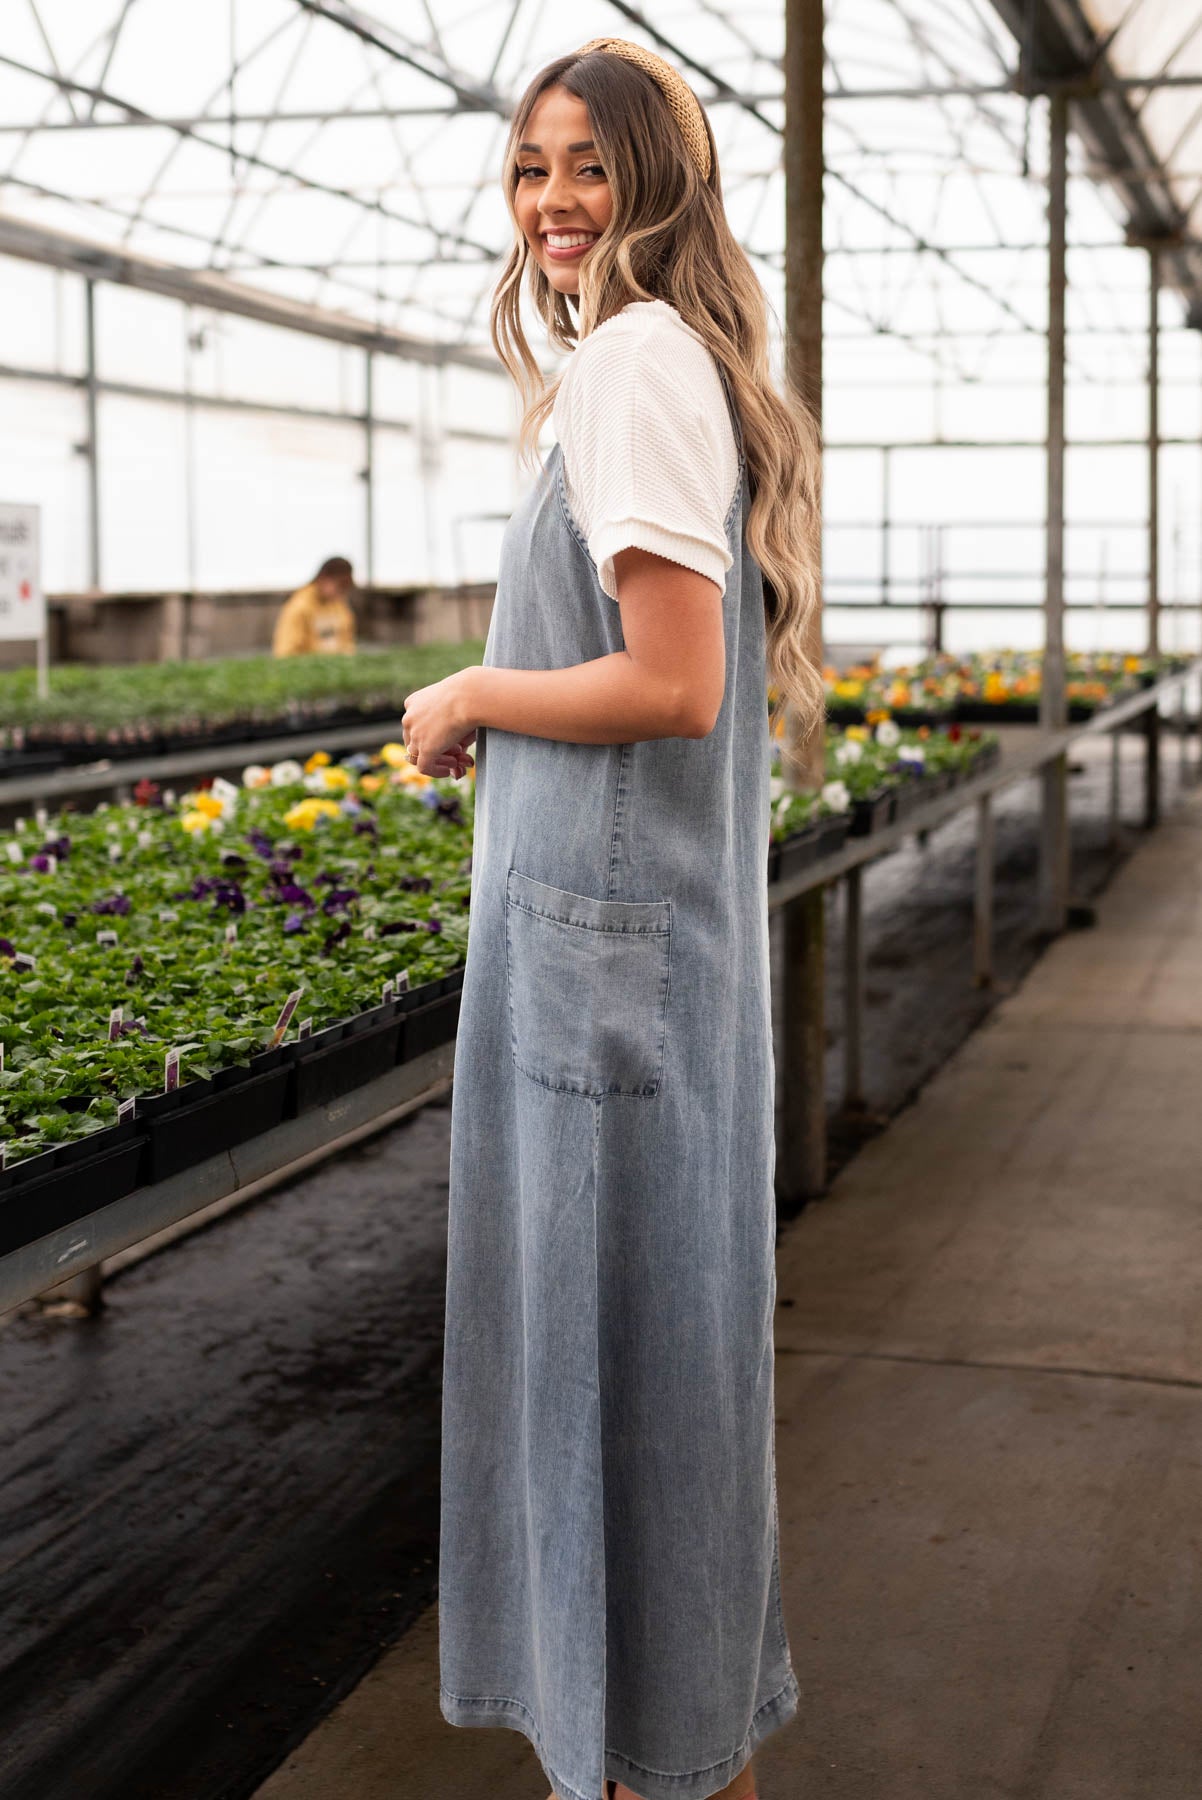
[513,85,614,293]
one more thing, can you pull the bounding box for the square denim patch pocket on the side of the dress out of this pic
[506,869,671,1098]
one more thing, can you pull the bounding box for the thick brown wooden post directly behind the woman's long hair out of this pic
[777,0,826,1204]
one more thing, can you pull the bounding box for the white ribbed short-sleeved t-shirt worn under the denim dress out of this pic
[551,301,738,599]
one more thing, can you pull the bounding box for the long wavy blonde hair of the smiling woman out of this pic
[489,50,826,736]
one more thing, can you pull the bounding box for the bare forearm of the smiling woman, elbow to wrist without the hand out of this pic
[462,650,714,743]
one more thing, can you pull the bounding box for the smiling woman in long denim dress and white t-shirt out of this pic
[405,40,822,1800]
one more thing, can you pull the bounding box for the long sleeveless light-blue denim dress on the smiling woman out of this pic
[439,354,797,1800]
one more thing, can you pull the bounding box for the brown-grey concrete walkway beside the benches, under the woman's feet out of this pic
[259,796,1202,1800]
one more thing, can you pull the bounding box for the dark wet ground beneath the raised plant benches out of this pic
[0,723,1177,1800]
